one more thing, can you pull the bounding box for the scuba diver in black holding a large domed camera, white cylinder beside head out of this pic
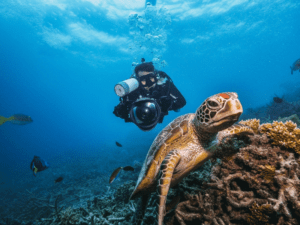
[113,58,186,131]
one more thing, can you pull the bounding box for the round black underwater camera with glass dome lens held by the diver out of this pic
[129,98,161,131]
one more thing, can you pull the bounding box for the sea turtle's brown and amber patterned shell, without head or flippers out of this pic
[130,113,195,199]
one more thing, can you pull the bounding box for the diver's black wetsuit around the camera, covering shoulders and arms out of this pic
[113,71,186,123]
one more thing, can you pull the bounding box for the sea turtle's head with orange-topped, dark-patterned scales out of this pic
[193,92,243,133]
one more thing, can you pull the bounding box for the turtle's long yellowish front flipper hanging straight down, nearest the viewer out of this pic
[158,150,180,225]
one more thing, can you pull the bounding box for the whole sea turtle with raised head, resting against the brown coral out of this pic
[130,92,253,225]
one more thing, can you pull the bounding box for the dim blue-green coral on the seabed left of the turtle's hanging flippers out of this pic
[30,181,135,225]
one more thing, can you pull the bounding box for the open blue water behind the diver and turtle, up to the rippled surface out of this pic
[0,0,300,221]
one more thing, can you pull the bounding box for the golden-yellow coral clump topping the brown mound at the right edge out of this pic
[259,121,300,154]
